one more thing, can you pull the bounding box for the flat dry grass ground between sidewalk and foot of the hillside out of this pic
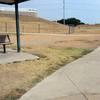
[0,34,100,100]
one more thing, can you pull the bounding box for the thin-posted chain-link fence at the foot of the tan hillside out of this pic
[0,22,40,33]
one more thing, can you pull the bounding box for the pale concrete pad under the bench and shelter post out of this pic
[0,49,39,64]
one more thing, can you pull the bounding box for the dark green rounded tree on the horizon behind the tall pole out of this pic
[57,18,84,26]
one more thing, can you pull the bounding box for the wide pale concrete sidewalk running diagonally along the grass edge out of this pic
[19,48,100,100]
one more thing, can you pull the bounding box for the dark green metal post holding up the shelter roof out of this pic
[15,3,21,52]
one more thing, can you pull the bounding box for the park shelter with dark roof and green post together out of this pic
[0,0,28,52]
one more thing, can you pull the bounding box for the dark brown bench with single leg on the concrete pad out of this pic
[0,35,11,53]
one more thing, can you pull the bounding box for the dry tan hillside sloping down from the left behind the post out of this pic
[0,12,68,33]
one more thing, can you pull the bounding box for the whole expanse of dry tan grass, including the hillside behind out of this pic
[0,9,100,100]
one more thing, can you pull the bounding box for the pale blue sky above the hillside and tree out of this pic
[0,0,100,24]
